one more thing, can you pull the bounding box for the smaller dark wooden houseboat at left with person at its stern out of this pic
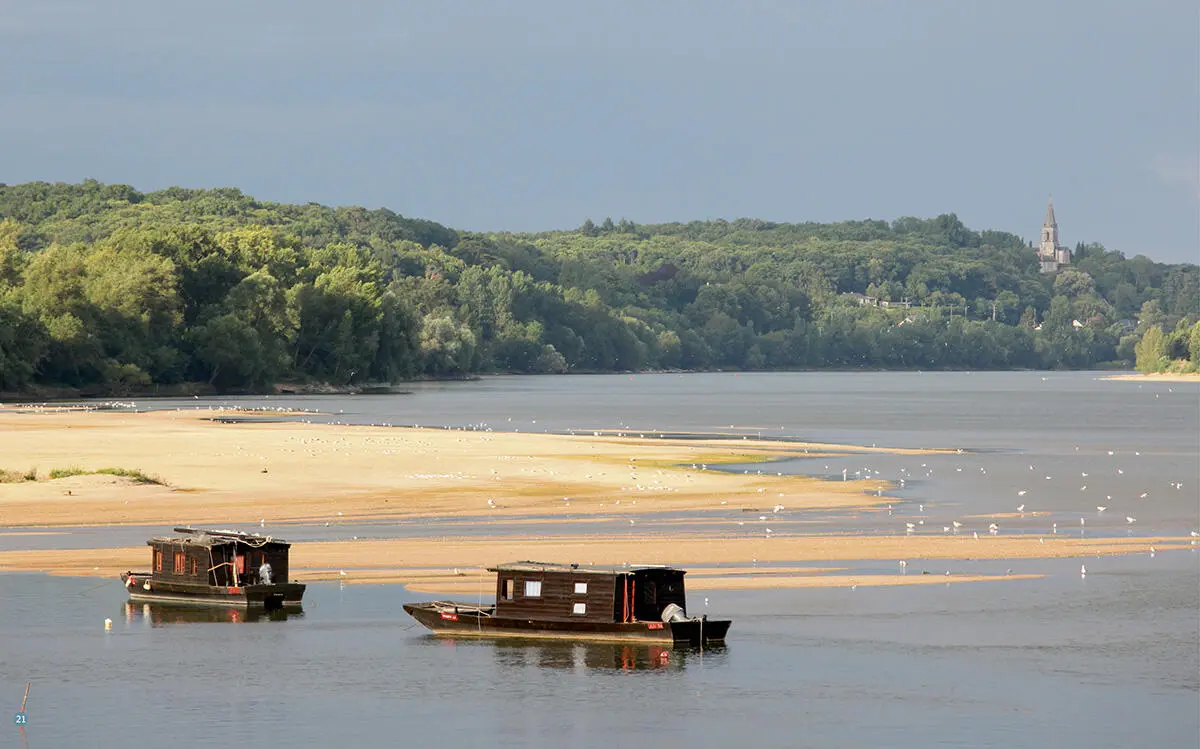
[121,528,305,611]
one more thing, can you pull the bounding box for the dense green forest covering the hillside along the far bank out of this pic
[0,181,1200,393]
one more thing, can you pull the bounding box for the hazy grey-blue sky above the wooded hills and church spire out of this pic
[0,0,1200,262]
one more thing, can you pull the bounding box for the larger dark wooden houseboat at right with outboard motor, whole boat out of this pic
[404,562,731,646]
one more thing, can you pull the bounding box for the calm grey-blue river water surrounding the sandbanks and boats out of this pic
[0,372,1200,749]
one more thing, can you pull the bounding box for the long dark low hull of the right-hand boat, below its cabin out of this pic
[404,604,731,646]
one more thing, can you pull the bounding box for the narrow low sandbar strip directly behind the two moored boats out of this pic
[0,535,1190,595]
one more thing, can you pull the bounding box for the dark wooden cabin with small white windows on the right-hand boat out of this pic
[488,562,688,623]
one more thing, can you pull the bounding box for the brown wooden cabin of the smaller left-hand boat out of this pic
[146,528,292,588]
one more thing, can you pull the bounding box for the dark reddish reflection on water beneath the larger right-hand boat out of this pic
[453,639,726,671]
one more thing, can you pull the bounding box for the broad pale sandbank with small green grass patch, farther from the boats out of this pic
[0,408,930,527]
